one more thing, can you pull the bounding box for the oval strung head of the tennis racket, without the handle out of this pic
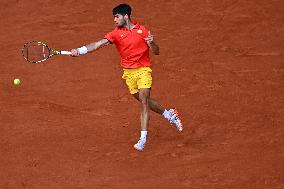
[22,42,51,63]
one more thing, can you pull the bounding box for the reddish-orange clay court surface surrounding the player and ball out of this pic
[0,0,284,189]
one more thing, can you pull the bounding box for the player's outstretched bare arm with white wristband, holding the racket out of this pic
[71,38,110,56]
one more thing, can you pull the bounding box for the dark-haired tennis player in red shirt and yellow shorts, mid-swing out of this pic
[71,4,183,151]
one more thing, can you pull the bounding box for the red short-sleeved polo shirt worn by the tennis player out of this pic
[104,21,151,68]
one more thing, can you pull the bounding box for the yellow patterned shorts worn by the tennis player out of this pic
[122,67,152,94]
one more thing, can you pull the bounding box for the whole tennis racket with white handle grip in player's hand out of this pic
[22,41,71,64]
